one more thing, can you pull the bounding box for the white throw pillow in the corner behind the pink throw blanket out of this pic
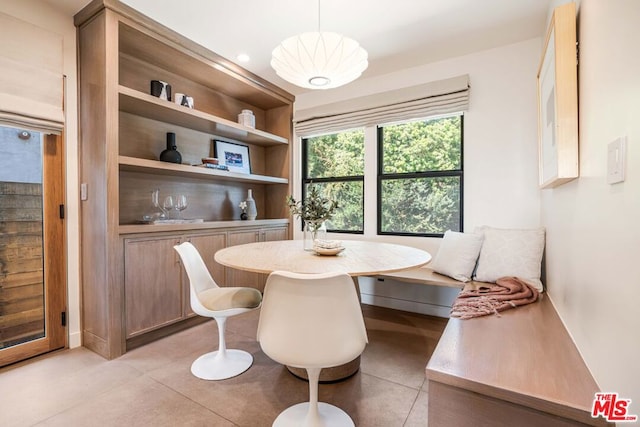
[474,227,544,292]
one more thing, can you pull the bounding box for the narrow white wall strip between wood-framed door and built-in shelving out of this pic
[0,0,81,347]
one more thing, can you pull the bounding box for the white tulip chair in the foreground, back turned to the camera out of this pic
[258,271,367,427]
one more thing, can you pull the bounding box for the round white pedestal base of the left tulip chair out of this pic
[191,350,253,380]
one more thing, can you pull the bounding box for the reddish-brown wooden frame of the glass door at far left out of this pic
[0,134,68,366]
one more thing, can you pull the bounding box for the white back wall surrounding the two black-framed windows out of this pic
[293,38,542,315]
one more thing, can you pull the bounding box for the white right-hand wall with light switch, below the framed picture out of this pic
[542,0,640,408]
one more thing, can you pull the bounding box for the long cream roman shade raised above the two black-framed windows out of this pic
[293,74,469,136]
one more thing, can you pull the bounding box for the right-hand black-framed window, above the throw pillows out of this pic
[378,115,463,236]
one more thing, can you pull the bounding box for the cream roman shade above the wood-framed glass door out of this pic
[0,13,64,133]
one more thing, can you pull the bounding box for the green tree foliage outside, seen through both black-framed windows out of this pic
[302,116,462,234]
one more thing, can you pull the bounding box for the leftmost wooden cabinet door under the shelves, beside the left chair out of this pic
[124,237,184,338]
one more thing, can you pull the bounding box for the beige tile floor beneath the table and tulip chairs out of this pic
[0,305,447,427]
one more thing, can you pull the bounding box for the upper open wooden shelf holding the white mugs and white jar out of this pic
[118,85,289,146]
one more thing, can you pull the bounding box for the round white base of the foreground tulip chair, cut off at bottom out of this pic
[273,402,355,427]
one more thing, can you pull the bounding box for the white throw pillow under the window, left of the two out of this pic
[429,230,482,282]
